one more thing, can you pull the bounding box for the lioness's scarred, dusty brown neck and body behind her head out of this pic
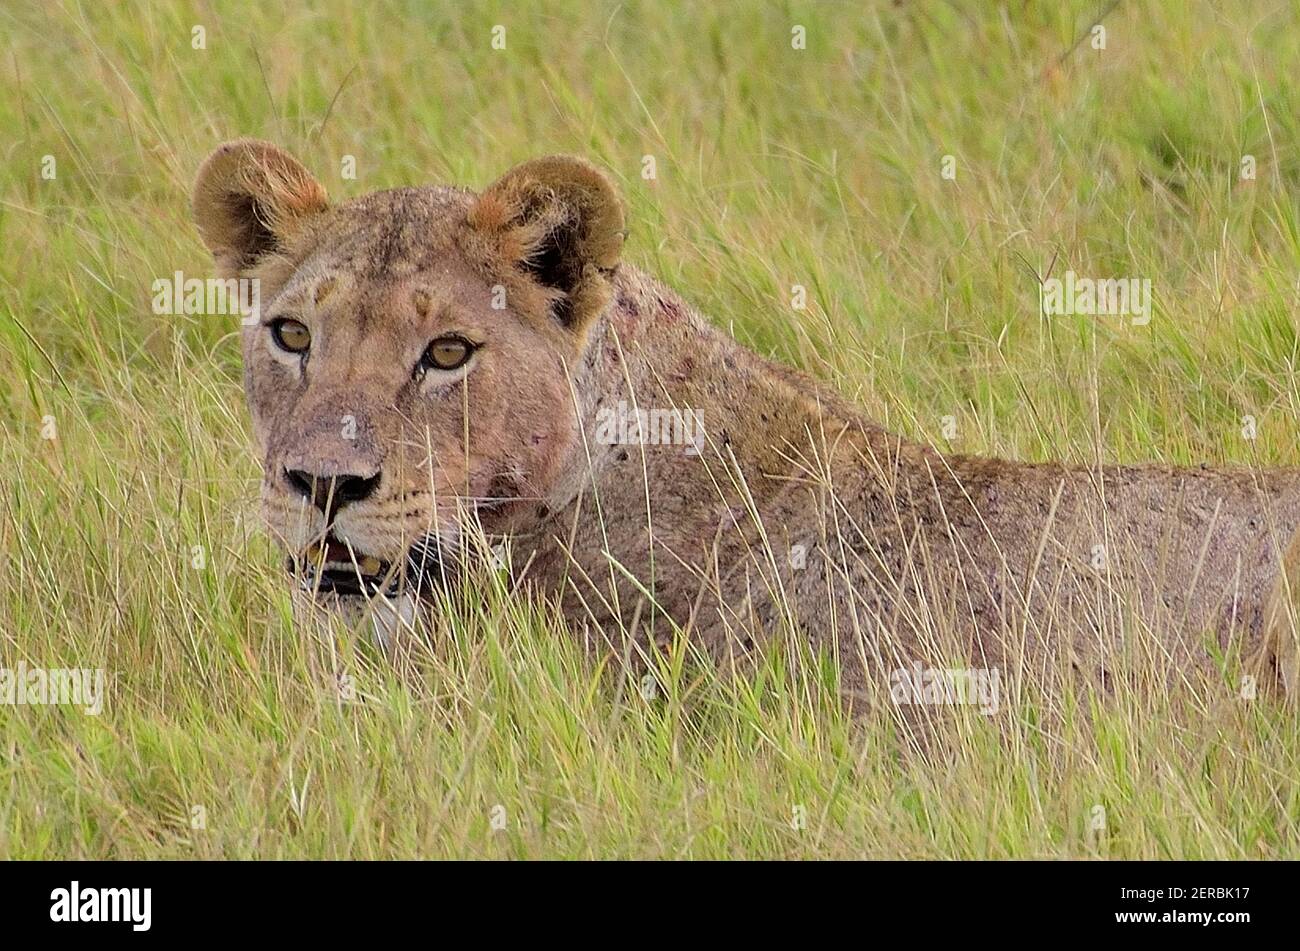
[515,263,1300,691]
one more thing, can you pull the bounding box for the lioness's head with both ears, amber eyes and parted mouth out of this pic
[194,140,624,595]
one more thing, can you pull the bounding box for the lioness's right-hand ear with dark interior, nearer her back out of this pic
[469,156,625,329]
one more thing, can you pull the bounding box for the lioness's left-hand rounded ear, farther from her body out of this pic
[194,139,329,277]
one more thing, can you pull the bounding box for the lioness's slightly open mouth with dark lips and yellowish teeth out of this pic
[285,533,451,598]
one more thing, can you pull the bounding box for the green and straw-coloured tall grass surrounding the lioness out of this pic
[0,0,1300,859]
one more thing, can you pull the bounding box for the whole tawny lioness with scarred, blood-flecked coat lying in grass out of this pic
[194,140,1300,696]
